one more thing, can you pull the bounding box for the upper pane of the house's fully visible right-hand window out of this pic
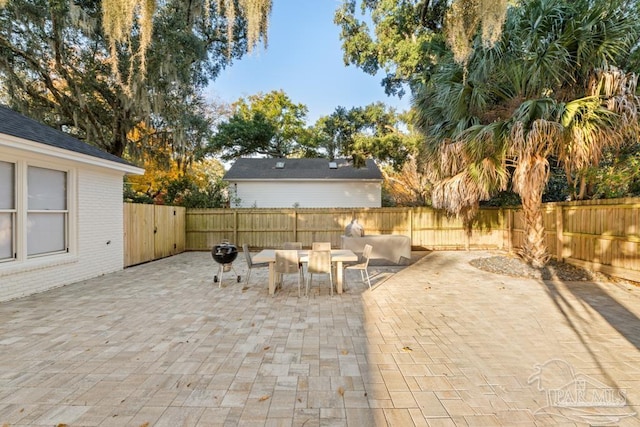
[27,166,67,210]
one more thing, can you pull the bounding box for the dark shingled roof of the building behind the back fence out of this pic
[224,158,382,181]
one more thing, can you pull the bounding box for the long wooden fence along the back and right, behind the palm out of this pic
[186,198,640,281]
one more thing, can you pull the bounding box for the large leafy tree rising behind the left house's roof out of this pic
[0,0,254,156]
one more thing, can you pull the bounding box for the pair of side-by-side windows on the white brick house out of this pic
[0,160,70,262]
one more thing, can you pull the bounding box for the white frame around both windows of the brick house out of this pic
[0,158,77,272]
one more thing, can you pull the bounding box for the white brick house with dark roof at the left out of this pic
[0,106,144,301]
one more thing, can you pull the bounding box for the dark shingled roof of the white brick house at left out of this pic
[0,105,135,166]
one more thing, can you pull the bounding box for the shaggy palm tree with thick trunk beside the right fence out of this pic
[413,0,640,266]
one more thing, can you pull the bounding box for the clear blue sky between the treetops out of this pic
[205,0,409,125]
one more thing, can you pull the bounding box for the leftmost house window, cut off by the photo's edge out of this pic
[0,162,16,261]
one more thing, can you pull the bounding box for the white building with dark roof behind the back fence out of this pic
[224,158,382,208]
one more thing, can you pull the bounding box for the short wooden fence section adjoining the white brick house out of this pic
[124,203,186,267]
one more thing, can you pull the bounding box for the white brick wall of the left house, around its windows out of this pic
[0,147,124,301]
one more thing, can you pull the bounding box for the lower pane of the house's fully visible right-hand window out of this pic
[27,213,67,255]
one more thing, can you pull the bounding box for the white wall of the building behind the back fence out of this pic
[230,181,382,208]
